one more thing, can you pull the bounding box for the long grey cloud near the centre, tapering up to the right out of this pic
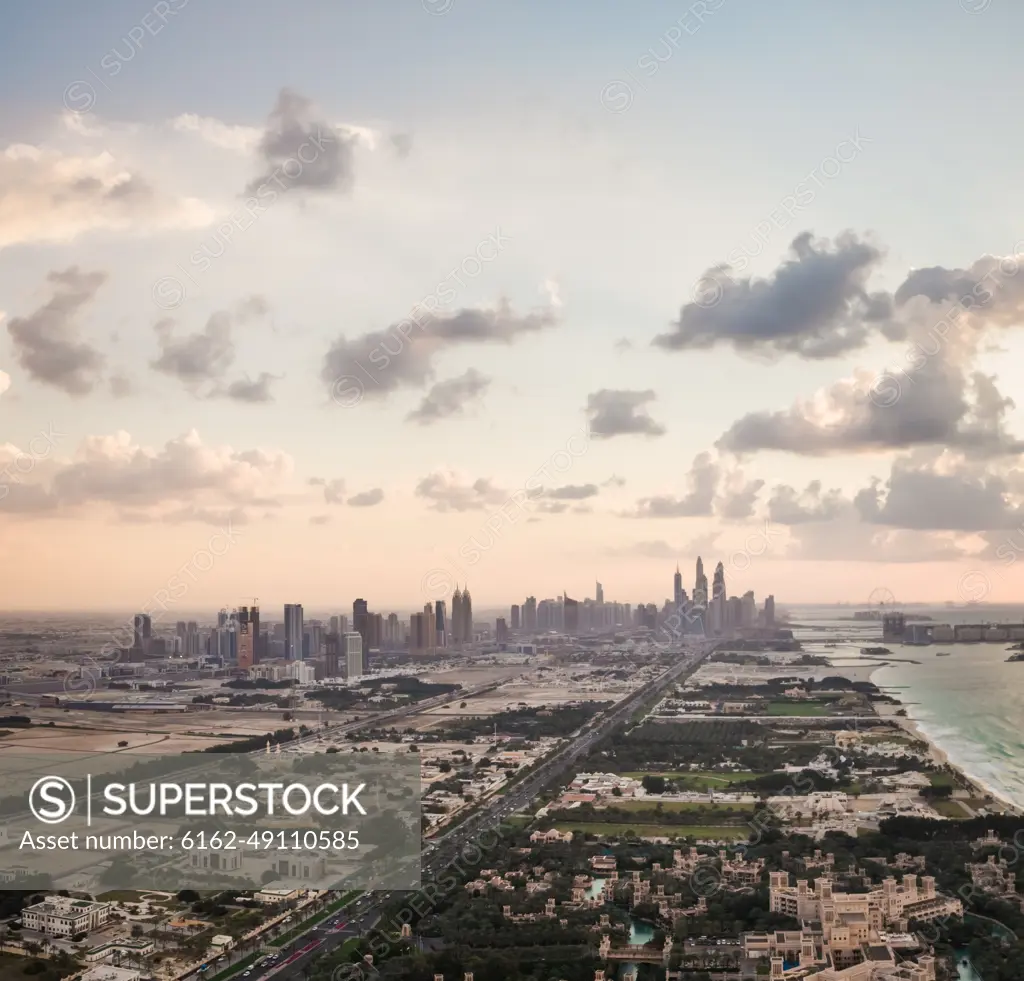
[321,300,557,399]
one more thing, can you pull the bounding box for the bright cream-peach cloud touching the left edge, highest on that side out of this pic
[0,144,215,249]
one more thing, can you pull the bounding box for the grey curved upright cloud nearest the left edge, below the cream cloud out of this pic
[7,266,106,395]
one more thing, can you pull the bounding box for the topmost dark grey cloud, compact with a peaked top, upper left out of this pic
[246,88,357,197]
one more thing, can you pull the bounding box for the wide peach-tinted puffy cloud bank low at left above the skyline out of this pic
[3,430,294,521]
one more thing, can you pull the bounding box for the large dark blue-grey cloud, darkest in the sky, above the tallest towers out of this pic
[653,231,892,358]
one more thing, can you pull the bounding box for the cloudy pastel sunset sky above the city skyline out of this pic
[0,0,1024,612]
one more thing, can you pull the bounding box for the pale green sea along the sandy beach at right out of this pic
[786,604,1024,807]
